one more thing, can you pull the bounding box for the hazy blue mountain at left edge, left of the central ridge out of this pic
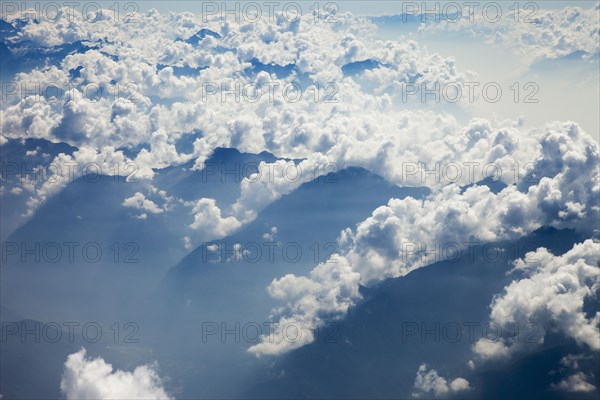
[0,144,275,318]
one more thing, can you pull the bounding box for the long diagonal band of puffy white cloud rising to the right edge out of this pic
[250,123,600,354]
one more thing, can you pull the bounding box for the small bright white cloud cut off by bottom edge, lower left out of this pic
[60,348,171,400]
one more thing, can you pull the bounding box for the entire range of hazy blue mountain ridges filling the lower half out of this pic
[1,140,600,399]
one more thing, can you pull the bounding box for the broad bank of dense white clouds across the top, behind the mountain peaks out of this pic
[0,10,482,219]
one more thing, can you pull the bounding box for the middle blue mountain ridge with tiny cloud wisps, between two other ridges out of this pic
[163,168,429,318]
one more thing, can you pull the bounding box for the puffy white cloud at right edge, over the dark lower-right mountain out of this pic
[473,239,600,358]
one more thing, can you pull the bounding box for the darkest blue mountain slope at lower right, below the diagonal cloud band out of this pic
[245,228,598,399]
